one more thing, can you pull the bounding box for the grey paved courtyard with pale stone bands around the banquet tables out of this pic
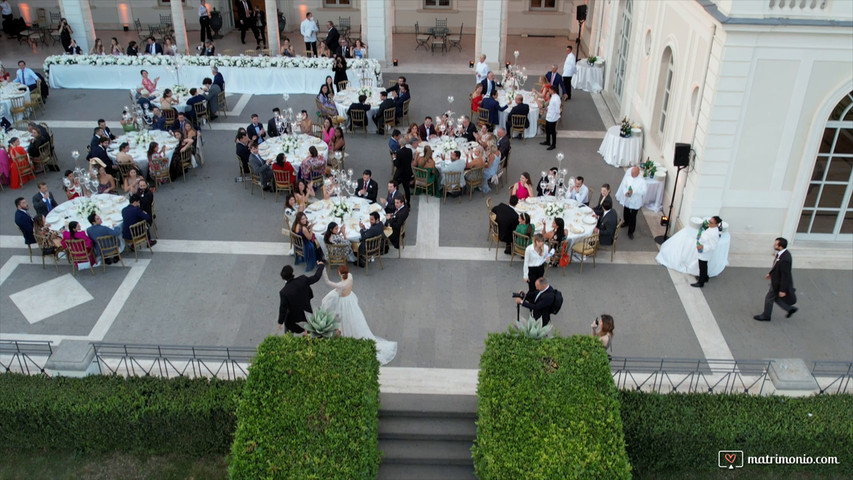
[0,42,853,378]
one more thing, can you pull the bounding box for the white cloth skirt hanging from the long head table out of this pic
[50,65,374,95]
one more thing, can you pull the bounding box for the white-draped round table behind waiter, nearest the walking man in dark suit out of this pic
[655,217,732,277]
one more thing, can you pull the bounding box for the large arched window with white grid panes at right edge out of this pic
[797,92,853,240]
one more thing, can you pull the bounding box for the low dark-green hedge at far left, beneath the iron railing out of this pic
[0,373,244,455]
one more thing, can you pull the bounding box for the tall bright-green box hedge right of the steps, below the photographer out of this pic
[471,333,631,480]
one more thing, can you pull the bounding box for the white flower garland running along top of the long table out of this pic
[44,55,382,81]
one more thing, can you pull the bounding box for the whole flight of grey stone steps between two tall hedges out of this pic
[379,393,477,480]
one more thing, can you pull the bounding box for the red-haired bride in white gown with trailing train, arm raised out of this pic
[320,265,397,365]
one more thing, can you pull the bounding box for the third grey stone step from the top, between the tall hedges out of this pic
[379,438,473,465]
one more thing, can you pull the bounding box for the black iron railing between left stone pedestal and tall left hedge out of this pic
[92,343,257,380]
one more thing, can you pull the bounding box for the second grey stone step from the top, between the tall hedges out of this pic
[379,416,477,442]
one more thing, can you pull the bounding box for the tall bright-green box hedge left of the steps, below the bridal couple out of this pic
[228,335,379,480]
